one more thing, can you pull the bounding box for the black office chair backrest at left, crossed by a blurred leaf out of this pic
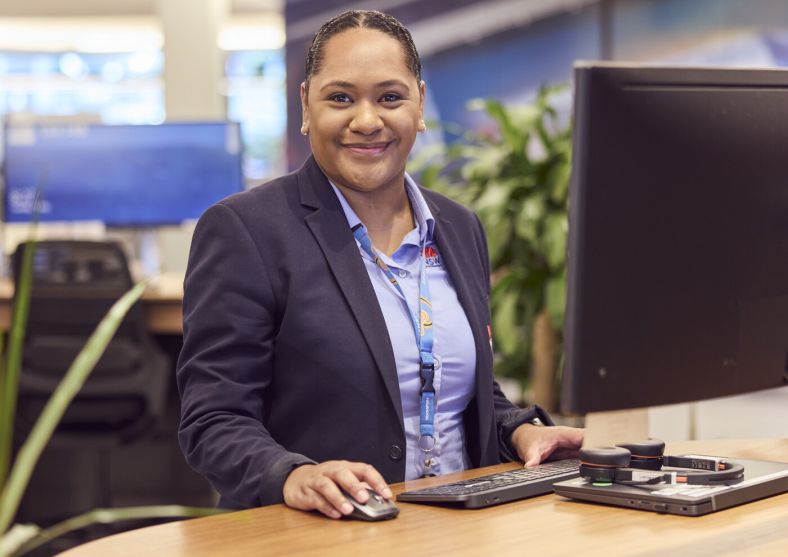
[13,240,168,434]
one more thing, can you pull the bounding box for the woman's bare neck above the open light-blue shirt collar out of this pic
[337,181,414,255]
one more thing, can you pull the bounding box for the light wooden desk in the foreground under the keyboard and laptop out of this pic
[61,439,788,557]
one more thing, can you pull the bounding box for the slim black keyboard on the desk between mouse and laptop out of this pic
[397,459,580,509]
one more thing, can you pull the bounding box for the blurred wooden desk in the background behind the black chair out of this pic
[0,273,183,335]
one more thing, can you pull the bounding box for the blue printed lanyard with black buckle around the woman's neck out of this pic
[353,223,435,452]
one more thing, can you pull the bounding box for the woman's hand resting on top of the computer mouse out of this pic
[282,460,392,518]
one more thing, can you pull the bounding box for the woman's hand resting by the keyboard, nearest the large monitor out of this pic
[512,424,584,466]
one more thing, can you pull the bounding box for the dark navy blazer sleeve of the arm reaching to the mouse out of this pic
[177,204,313,508]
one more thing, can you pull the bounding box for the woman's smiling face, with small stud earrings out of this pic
[301,29,424,198]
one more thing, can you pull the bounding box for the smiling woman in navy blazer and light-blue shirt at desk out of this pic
[178,11,582,518]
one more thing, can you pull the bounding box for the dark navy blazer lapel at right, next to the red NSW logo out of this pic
[427,195,497,461]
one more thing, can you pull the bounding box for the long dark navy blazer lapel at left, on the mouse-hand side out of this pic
[298,156,404,428]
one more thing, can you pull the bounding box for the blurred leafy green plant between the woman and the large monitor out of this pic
[412,87,572,408]
